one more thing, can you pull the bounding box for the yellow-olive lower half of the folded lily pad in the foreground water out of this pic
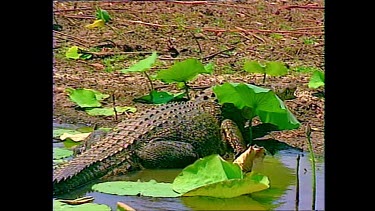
[182,173,270,198]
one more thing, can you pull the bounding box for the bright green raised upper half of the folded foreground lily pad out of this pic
[173,154,243,194]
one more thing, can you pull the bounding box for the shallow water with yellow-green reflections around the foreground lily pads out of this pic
[54,150,324,210]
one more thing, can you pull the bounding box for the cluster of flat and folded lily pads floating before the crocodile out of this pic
[92,155,269,198]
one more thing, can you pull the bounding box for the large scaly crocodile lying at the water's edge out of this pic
[53,89,258,195]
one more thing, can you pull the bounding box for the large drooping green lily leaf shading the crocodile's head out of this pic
[213,83,300,130]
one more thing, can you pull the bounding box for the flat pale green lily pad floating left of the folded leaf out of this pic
[92,180,181,197]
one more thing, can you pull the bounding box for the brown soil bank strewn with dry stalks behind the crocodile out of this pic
[53,0,324,154]
